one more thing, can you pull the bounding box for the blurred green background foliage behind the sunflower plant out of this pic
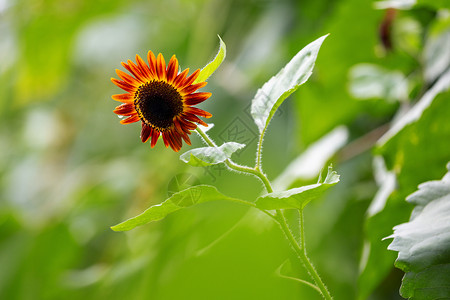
[0,0,450,299]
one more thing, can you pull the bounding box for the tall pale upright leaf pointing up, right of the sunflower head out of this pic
[251,35,328,134]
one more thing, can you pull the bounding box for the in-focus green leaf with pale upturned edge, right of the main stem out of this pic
[256,166,339,209]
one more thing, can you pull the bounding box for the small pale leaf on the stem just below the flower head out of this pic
[180,142,245,167]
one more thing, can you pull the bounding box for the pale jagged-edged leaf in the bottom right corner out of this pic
[388,163,450,299]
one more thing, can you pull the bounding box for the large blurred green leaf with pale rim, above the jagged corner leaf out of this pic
[358,84,450,299]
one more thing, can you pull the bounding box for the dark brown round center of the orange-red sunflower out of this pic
[134,80,183,130]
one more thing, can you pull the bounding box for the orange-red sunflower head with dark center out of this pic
[111,51,212,152]
